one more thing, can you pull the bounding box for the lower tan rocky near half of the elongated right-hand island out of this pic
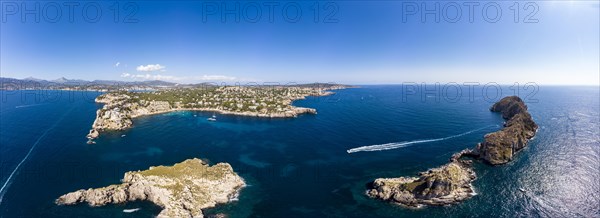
[367,162,476,207]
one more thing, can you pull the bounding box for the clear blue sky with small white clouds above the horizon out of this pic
[0,1,600,85]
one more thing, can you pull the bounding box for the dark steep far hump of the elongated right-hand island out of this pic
[475,96,538,165]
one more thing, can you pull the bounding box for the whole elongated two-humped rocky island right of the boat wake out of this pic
[367,96,538,207]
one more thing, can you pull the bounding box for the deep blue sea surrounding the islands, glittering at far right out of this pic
[0,86,600,217]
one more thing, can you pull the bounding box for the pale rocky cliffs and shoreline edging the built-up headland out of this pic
[87,86,344,143]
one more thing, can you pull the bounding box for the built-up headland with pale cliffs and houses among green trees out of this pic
[87,84,347,142]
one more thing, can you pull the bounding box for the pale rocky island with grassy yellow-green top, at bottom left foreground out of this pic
[56,158,245,217]
